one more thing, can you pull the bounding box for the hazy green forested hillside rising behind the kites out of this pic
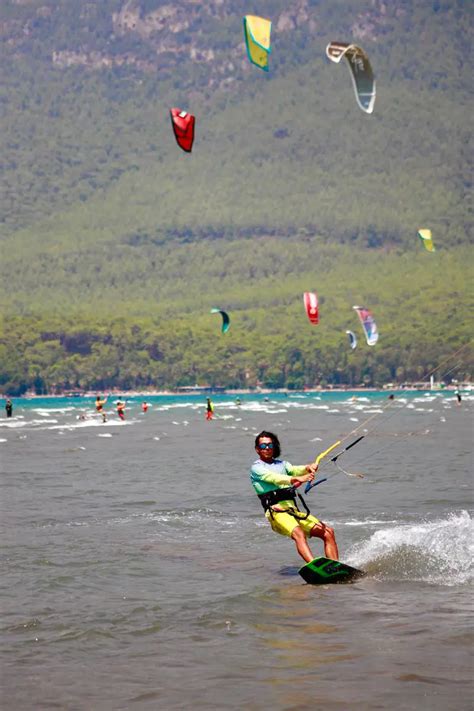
[0,0,473,394]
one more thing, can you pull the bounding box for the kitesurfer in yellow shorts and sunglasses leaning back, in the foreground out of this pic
[250,431,339,563]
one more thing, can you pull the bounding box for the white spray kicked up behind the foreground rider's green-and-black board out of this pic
[348,511,474,586]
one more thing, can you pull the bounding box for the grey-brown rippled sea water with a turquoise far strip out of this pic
[0,393,474,711]
